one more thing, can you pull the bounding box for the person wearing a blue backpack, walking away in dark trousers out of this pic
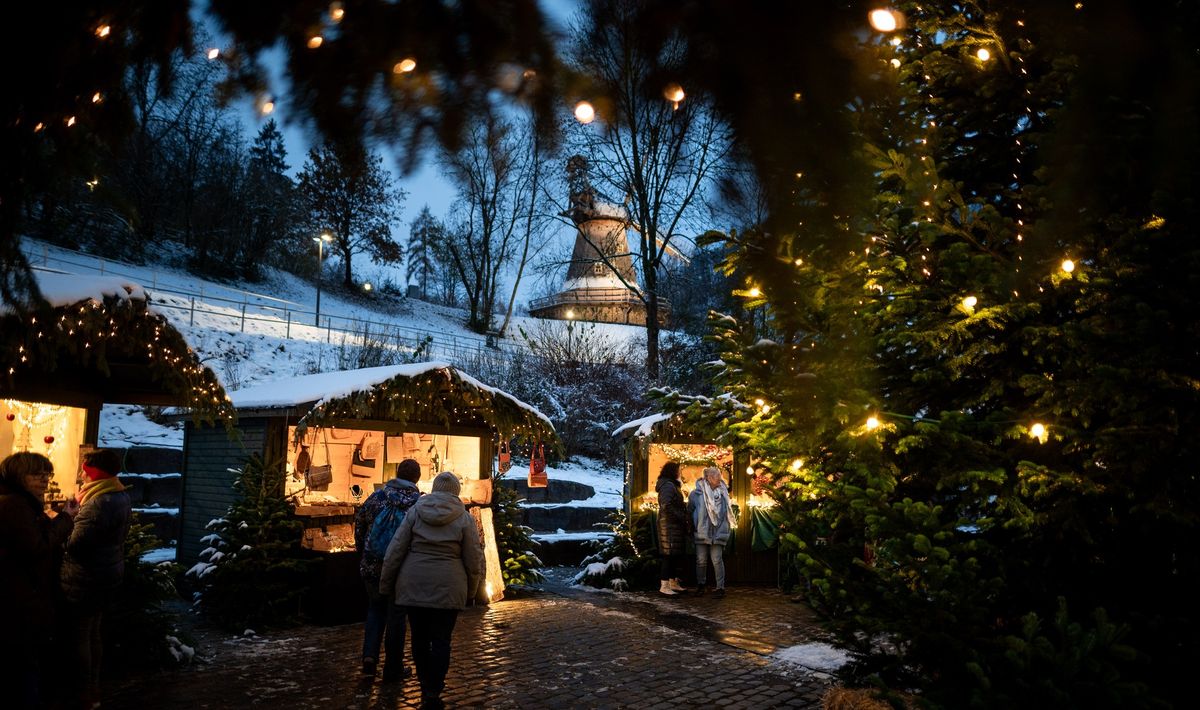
[354,458,421,682]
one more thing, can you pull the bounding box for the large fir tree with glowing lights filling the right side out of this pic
[713,2,1200,706]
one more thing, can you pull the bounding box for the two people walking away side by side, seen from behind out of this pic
[355,459,484,708]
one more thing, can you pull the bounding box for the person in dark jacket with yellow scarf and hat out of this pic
[61,449,130,708]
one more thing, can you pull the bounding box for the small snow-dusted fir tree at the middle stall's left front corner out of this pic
[187,456,311,628]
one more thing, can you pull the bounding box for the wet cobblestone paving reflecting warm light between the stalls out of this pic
[103,580,830,710]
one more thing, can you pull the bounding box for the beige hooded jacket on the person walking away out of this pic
[379,491,484,609]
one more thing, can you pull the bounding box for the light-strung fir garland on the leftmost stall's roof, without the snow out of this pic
[0,287,234,427]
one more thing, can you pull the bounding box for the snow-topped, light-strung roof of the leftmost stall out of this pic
[0,271,233,421]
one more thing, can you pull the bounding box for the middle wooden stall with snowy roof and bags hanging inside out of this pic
[179,362,558,619]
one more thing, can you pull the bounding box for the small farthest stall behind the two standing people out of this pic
[613,414,779,584]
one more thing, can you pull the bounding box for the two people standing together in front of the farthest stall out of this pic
[655,462,732,598]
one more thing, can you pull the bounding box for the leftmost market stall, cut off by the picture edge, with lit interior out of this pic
[0,271,233,503]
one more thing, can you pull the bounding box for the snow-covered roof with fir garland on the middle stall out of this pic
[230,362,558,445]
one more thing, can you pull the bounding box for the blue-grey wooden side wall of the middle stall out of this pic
[176,417,286,565]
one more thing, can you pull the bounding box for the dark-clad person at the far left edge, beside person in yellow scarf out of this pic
[0,452,78,708]
